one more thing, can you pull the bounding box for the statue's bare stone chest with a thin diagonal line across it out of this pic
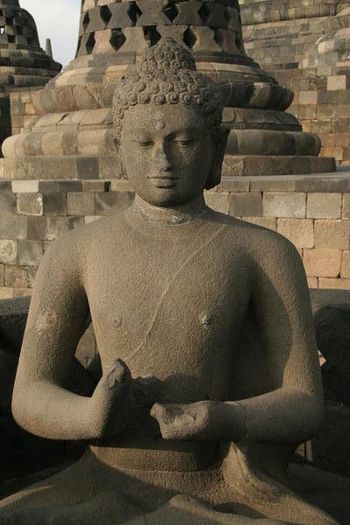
[83,223,250,400]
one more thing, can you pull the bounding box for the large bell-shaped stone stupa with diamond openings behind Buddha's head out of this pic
[3,0,334,179]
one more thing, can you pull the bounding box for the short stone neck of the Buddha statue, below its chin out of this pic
[130,195,208,226]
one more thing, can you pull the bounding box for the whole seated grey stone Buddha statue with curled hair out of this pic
[0,39,336,525]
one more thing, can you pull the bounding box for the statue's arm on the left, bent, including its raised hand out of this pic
[12,234,131,439]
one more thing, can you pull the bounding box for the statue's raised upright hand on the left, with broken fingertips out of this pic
[89,359,132,438]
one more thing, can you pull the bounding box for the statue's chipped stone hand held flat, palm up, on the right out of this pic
[151,401,245,441]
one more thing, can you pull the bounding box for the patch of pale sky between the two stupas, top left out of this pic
[19,0,81,65]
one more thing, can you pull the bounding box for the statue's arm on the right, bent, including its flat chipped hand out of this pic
[152,232,324,445]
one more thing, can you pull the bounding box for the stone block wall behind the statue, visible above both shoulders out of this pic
[0,173,350,298]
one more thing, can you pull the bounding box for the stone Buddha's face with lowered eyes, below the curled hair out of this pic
[120,104,214,207]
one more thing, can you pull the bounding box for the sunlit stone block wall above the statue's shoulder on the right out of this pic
[207,175,350,290]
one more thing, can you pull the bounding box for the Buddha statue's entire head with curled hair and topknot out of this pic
[113,38,227,207]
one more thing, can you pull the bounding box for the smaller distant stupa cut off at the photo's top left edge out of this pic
[0,0,61,145]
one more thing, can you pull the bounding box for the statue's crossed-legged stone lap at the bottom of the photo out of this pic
[0,450,288,525]
